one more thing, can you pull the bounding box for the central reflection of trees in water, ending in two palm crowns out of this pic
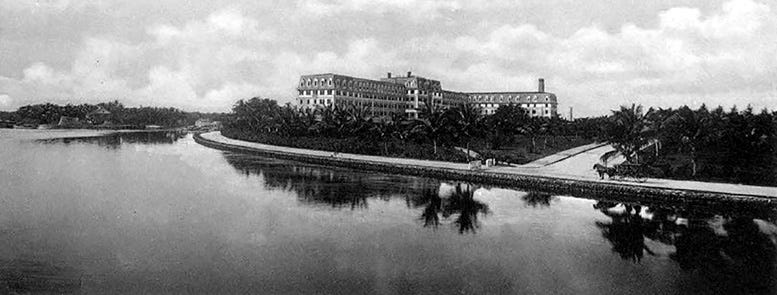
[224,153,489,234]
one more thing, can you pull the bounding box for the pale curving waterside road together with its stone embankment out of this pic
[193,132,777,205]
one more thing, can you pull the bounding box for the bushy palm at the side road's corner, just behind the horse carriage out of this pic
[601,104,655,164]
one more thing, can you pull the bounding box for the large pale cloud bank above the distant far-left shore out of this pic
[0,8,272,111]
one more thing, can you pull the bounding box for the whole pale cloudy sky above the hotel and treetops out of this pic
[0,0,777,117]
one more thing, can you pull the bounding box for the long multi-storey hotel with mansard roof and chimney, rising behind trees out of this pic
[297,72,558,118]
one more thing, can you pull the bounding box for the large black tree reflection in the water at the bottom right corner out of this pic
[593,201,777,293]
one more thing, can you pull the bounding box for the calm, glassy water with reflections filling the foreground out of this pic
[0,129,777,294]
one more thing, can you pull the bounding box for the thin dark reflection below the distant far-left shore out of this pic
[39,130,187,149]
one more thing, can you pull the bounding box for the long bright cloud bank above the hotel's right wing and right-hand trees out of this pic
[406,0,777,114]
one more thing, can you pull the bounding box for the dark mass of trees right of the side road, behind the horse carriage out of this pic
[602,105,777,185]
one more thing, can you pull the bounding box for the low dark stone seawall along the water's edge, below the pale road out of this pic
[194,133,777,207]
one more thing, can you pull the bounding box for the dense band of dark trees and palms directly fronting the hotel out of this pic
[222,97,605,163]
